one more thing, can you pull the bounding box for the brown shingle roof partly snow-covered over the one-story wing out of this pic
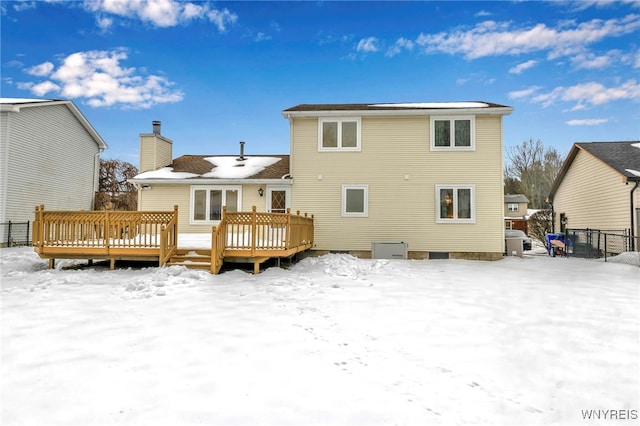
[129,155,289,183]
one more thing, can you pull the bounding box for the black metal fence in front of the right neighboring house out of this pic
[565,229,640,261]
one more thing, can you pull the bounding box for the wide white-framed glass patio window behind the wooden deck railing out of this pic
[190,186,242,224]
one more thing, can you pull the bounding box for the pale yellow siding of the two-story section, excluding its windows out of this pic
[291,116,504,252]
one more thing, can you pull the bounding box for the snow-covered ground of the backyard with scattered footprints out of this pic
[0,248,640,426]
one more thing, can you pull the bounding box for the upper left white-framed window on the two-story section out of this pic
[318,117,360,151]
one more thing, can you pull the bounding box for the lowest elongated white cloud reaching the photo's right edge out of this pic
[532,80,640,111]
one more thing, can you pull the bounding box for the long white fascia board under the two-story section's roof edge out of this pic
[282,107,513,119]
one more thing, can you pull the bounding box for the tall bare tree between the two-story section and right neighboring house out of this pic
[505,139,562,209]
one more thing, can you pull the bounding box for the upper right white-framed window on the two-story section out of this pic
[431,117,475,151]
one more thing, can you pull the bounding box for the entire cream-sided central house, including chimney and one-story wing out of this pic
[130,102,513,259]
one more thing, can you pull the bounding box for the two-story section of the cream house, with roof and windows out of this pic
[282,102,513,259]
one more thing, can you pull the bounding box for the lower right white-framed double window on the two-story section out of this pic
[436,185,476,223]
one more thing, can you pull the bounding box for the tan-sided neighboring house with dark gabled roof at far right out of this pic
[549,141,640,236]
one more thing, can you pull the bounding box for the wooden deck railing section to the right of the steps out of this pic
[211,206,314,274]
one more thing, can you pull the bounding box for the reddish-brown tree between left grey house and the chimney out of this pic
[95,159,138,210]
